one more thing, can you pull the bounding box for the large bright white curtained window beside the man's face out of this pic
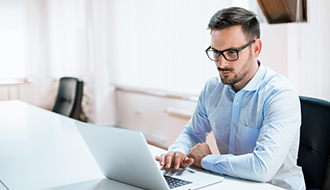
[109,0,240,95]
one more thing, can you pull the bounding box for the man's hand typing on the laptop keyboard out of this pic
[155,151,194,170]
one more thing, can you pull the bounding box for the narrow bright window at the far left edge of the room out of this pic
[0,0,26,81]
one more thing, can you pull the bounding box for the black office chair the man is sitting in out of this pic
[298,96,330,189]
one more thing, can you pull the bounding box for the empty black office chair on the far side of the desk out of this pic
[52,77,84,119]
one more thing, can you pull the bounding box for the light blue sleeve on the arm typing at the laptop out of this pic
[169,83,211,154]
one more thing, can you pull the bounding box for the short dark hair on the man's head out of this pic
[208,7,260,41]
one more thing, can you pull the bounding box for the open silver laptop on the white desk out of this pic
[75,121,224,190]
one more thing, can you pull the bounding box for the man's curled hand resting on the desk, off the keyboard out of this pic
[187,143,212,168]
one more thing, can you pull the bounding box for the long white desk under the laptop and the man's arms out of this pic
[0,101,280,190]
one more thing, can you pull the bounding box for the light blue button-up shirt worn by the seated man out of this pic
[169,65,305,189]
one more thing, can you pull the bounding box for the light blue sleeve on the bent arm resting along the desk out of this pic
[201,89,301,182]
